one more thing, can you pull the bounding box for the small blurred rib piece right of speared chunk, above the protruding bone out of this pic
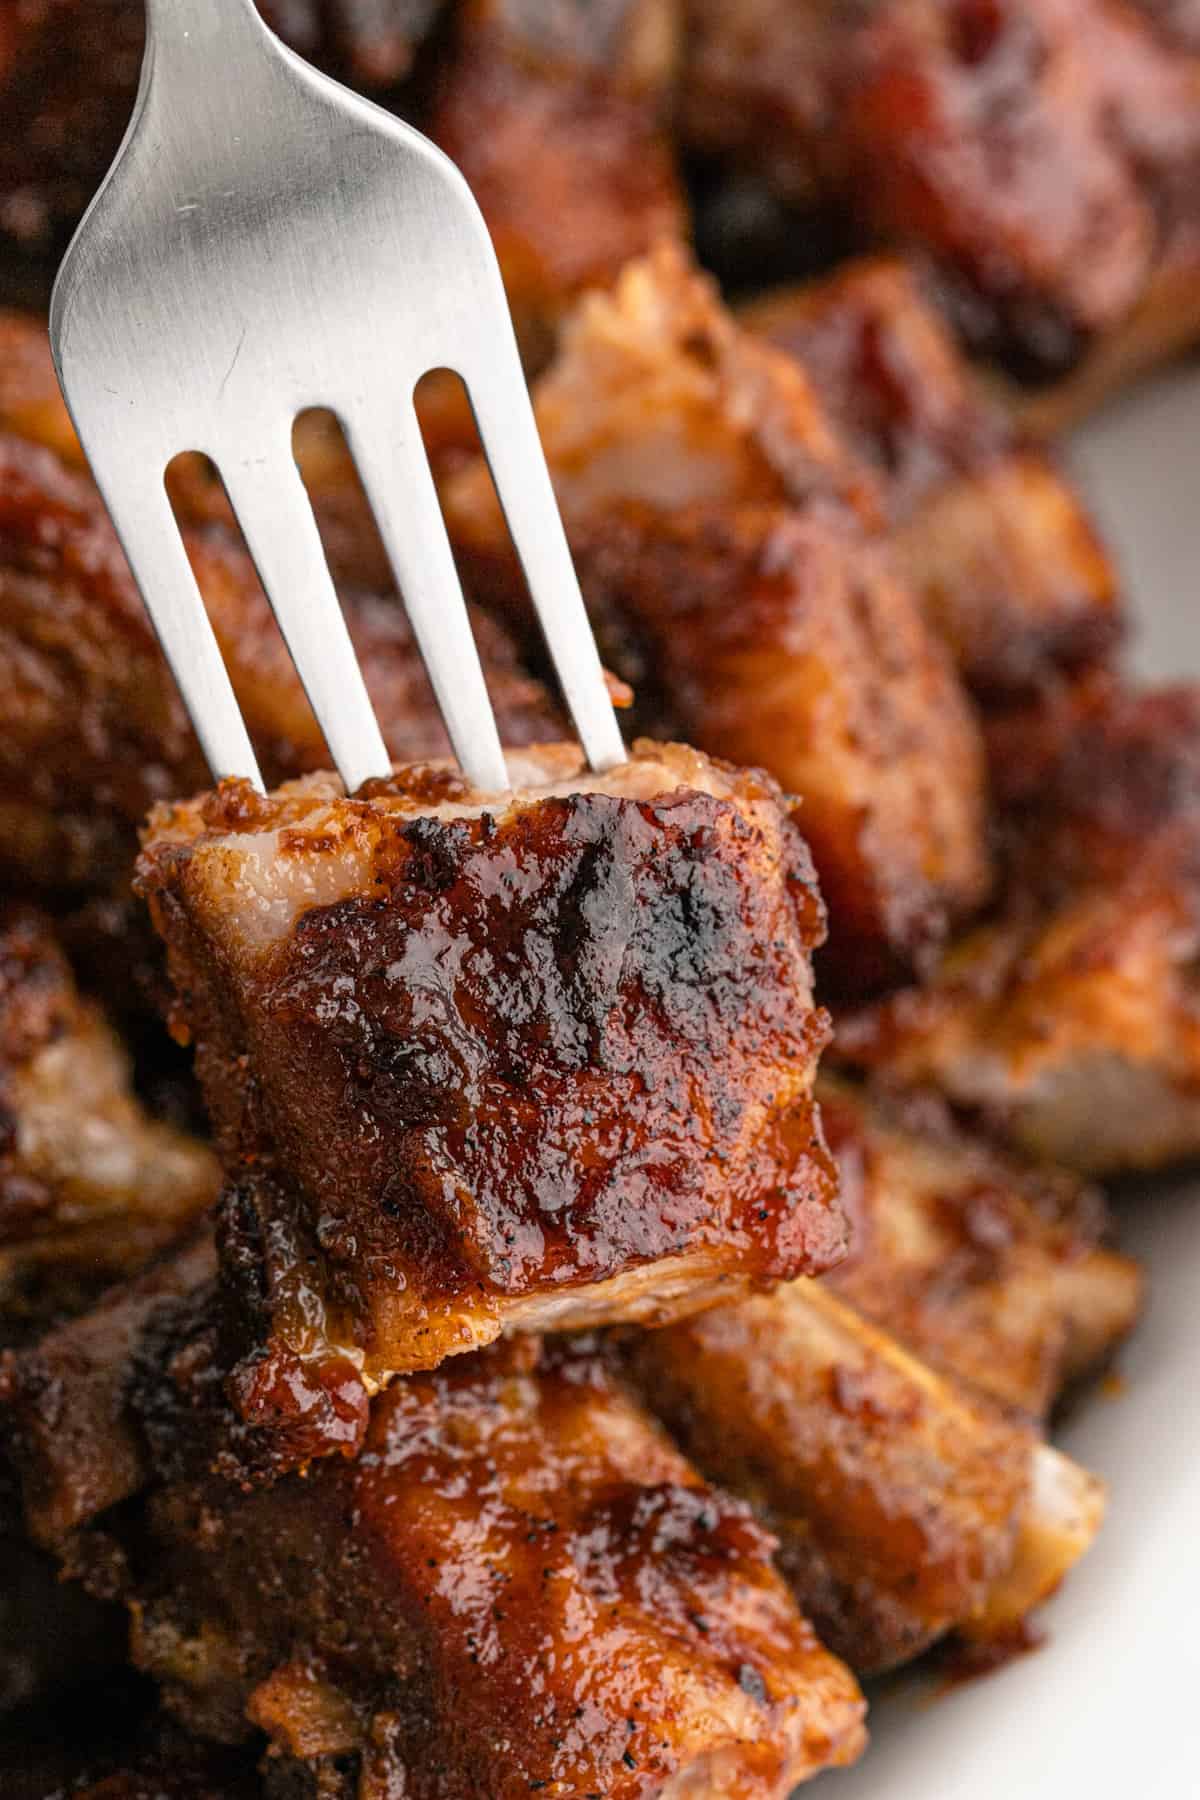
[819,1076,1142,1420]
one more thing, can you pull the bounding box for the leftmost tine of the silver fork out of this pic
[95,457,263,788]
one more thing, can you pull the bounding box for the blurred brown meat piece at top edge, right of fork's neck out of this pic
[425,0,685,365]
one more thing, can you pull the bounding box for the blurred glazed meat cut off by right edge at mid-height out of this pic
[837,682,1200,1172]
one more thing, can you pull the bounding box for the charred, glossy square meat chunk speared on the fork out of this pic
[140,743,844,1404]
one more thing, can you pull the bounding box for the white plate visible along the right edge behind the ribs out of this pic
[819,367,1200,1800]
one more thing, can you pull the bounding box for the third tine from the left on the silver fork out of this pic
[345,405,509,794]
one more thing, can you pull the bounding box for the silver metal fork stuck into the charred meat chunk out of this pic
[50,0,624,792]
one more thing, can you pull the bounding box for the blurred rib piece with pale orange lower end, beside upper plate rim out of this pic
[743,257,1123,706]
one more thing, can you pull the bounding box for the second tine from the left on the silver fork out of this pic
[218,446,392,794]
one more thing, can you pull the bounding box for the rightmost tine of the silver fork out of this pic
[464,344,626,769]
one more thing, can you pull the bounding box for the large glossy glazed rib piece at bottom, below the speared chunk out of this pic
[0,1267,864,1800]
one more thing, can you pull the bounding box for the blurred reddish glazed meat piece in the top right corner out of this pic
[684,0,1200,373]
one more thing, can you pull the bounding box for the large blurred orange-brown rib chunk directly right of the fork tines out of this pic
[446,248,988,992]
